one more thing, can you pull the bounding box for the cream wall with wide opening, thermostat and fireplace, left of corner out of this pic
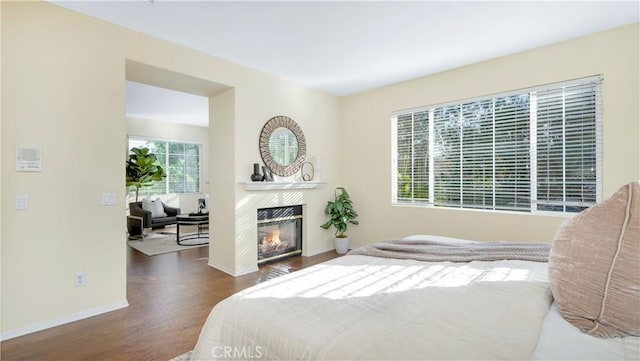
[0,1,340,339]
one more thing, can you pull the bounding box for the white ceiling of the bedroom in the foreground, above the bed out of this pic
[52,0,640,126]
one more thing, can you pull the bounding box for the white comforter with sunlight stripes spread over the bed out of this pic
[192,256,551,360]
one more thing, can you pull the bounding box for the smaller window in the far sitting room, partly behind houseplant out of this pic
[129,137,201,195]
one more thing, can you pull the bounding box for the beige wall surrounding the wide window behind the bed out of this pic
[342,24,640,245]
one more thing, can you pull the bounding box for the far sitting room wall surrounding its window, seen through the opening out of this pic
[127,117,209,213]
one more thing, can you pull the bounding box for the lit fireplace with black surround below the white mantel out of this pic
[258,205,302,264]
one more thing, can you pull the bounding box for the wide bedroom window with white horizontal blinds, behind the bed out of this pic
[392,77,602,212]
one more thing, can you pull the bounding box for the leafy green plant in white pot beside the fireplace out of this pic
[320,187,358,254]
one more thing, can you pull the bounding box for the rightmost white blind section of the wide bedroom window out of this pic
[534,83,601,212]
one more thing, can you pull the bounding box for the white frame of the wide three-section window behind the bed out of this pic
[391,75,603,212]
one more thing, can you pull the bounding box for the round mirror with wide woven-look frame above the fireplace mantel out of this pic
[259,115,307,177]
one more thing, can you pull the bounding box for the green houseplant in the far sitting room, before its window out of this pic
[126,148,167,202]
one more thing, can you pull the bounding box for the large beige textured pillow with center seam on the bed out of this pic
[549,182,640,337]
